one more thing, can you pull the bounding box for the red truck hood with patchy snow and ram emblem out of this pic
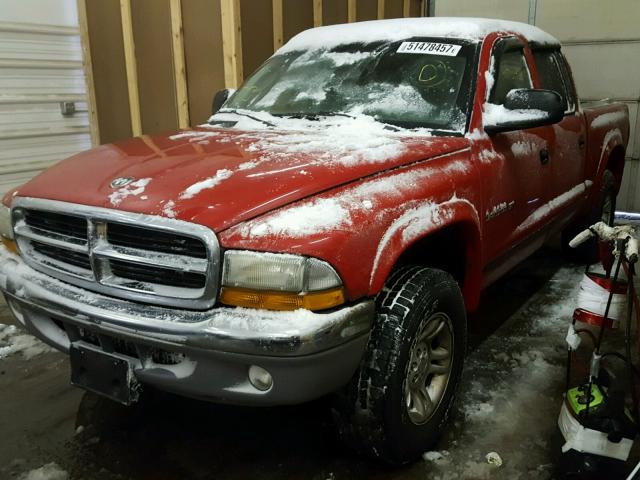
[12,122,468,232]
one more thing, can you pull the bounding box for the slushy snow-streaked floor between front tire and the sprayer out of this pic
[423,266,583,480]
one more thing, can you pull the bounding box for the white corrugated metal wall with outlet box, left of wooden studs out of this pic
[0,0,91,195]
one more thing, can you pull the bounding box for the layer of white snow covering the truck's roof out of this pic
[277,17,560,53]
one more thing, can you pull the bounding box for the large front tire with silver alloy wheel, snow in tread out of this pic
[334,266,467,465]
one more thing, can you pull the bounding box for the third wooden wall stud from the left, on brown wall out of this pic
[169,0,189,128]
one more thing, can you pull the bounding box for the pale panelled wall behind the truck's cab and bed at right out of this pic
[431,0,640,211]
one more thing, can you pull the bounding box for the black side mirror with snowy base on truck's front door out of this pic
[483,88,564,134]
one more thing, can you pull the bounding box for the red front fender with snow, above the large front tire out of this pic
[219,149,480,300]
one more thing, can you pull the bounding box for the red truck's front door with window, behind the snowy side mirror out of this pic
[477,37,553,283]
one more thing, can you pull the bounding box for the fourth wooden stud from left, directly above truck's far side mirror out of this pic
[220,0,243,88]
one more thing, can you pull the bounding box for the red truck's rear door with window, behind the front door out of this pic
[533,47,586,226]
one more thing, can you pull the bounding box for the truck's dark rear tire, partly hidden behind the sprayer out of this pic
[562,170,616,264]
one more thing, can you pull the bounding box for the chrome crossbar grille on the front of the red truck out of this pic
[12,197,219,309]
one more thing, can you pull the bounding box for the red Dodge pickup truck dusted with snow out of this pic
[0,18,629,463]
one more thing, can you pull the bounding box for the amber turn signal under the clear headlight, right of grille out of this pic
[220,287,345,310]
